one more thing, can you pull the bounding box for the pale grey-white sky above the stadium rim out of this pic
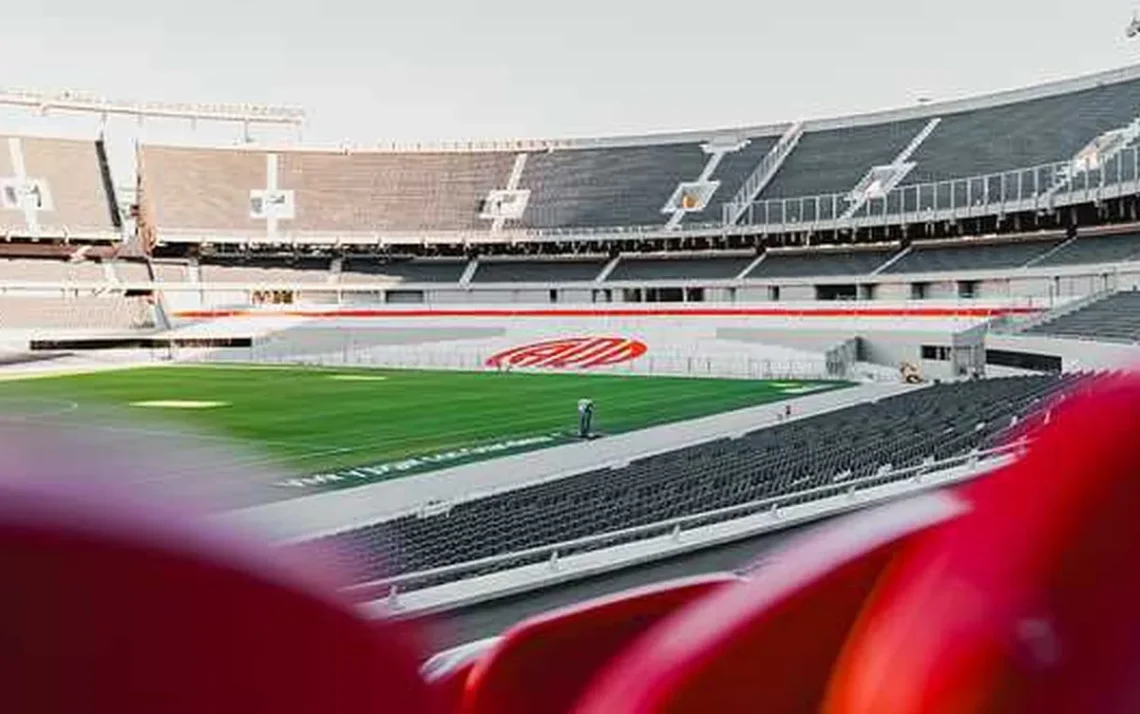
[0,0,1140,145]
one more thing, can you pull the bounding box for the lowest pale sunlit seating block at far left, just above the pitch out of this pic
[0,295,154,330]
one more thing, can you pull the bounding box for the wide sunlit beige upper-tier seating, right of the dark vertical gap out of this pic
[140,145,517,235]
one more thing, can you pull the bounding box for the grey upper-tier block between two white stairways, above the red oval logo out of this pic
[519,144,708,228]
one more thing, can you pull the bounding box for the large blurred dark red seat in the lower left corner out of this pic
[0,458,429,714]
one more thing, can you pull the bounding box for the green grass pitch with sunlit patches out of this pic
[0,366,844,480]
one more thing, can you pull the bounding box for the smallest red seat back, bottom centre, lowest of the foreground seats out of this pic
[462,574,740,714]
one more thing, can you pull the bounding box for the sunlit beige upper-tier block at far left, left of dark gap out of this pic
[0,135,119,237]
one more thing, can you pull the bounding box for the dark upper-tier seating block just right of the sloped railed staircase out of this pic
[760,119,927,200]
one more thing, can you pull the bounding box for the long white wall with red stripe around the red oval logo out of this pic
[144,301,1003,378]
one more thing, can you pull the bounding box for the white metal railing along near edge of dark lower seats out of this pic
[344,441,1025,594]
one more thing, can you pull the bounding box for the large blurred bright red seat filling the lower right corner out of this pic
[825,369,1140,714]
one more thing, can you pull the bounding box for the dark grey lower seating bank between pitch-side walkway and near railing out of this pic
[299,375,1078,584]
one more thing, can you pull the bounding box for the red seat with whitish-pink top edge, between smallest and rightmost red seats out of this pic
[573,494,968,714]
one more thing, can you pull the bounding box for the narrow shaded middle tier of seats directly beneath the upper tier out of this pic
[15,233,1140,284]
